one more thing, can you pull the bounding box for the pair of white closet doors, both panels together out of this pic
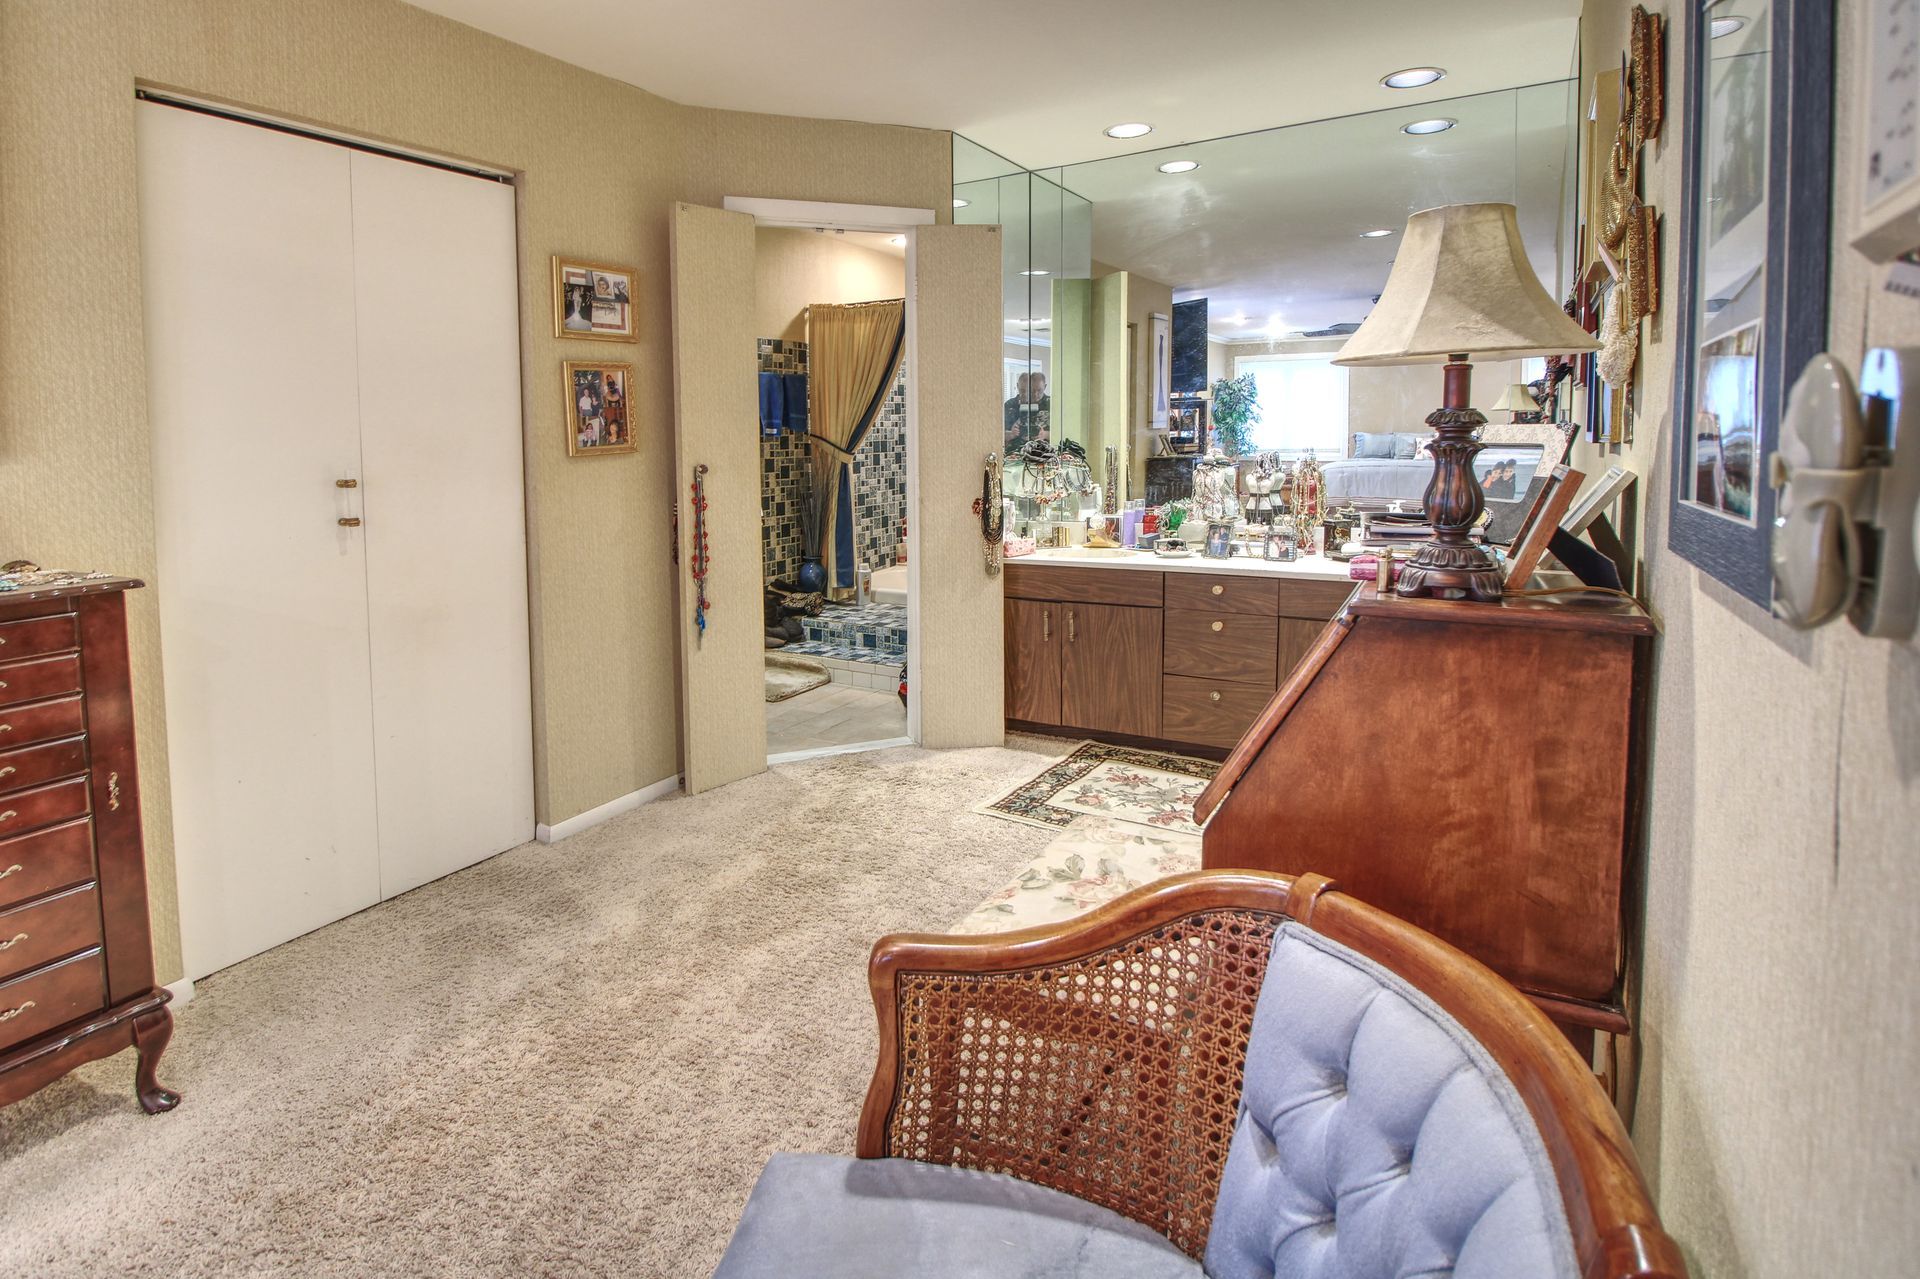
[138,104,534,977]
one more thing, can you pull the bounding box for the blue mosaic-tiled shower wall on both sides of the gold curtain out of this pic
[760,338,906,582]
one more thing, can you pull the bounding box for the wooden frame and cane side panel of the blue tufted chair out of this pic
[858,870,1686,1279]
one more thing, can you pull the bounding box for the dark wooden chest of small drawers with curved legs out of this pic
[0,578,180,1114]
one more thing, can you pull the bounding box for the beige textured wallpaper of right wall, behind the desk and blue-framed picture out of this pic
[1582,0,1920,1277]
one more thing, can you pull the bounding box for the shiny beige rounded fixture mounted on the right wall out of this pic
[1768,348,1920,640]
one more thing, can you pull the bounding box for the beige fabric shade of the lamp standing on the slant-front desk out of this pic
[1332,204,1599,365]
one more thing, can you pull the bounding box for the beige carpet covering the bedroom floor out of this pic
[0,743,1050,1277]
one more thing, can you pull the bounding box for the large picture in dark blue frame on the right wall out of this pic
[1667,0,1834,609]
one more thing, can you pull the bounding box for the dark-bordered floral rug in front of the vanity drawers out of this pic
[973,741,1219,835]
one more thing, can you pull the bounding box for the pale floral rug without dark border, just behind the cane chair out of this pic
[952,816,1200,933]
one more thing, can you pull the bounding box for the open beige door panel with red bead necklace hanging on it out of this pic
[672,204,766,795]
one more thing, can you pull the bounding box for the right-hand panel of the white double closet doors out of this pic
[351,154,533,897]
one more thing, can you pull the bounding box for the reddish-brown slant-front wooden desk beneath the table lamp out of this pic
[1194,584,1655,1047]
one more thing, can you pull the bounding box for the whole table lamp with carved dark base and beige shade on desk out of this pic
[1332,204,1599,599]
